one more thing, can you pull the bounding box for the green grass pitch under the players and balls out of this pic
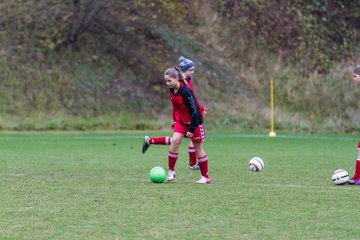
[0,132,360,240]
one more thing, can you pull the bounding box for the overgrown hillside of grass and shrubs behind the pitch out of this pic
[0,0,360,131]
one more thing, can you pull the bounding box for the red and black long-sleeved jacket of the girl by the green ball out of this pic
[170,82,203,133]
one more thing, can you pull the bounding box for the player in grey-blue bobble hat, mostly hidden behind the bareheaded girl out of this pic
[142,56,206,170]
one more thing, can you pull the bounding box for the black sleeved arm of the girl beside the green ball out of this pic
[182,87,202,133]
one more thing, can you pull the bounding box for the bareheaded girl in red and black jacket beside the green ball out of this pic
[164,68,210,184]
